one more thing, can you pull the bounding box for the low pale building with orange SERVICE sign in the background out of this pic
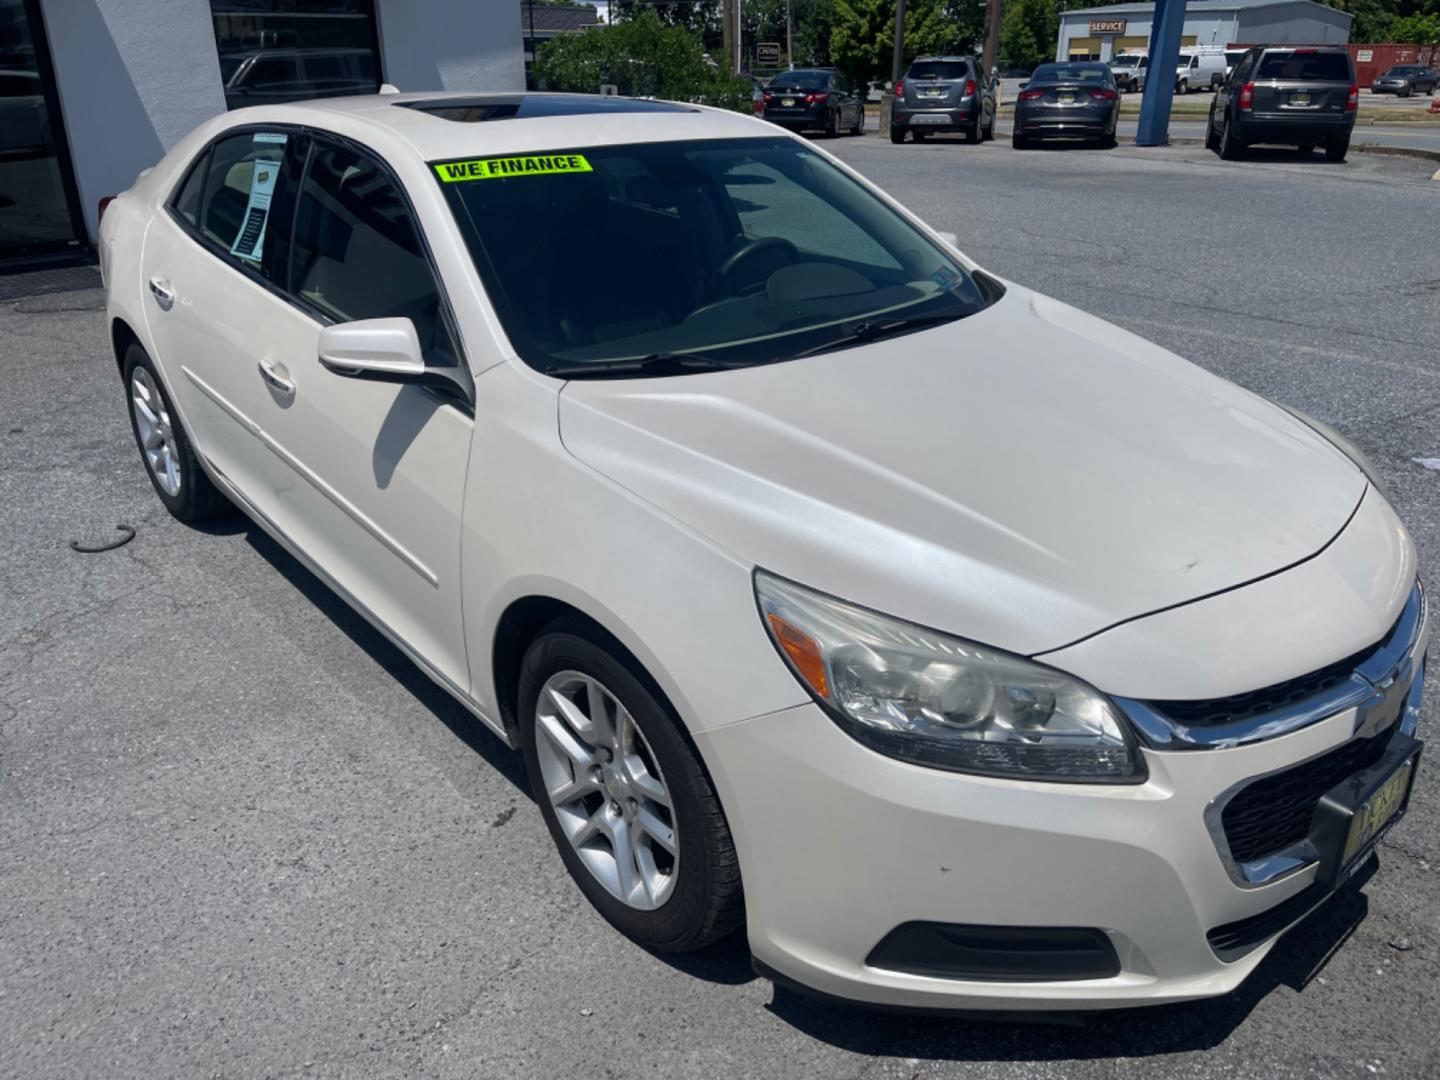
[1056,0,1355,60]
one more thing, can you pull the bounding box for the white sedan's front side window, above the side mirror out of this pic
[289,140,455,364]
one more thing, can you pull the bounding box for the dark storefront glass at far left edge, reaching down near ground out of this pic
[0,0,78,258]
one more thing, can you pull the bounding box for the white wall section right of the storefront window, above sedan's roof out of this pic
[374,0,526,91]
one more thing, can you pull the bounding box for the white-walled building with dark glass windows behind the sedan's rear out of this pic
[0,0,524,271]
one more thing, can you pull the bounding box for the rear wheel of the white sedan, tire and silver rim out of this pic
[124,344,235,524]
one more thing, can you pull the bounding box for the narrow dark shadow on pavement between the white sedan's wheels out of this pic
[235,521,534,801]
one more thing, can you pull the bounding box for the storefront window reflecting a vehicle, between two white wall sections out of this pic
[210,0,380,109]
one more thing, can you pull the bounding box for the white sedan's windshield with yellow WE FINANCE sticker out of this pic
[433,137,999,376]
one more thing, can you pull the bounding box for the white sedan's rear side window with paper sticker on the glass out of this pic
[195,131,291,278]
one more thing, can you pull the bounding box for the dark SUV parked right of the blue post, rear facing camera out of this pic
[1205,45,1359,161]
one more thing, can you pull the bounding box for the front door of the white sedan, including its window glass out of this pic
[246,138,474,691]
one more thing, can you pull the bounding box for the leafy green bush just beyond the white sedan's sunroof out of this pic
[534,10,752,112]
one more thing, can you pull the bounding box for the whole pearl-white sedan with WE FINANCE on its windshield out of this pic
[101,94,1428,1009]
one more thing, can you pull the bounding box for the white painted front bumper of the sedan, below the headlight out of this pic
[697,639,1418,1011]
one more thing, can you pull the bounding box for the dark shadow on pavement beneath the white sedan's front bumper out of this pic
[766,858,1377,1061]
